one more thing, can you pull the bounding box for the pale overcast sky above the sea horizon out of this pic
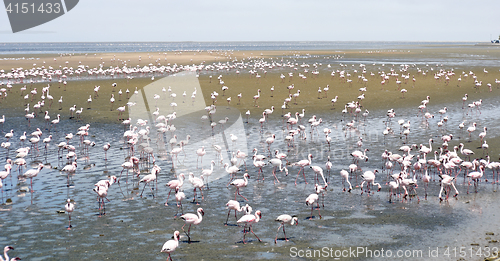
[0,0,500,42]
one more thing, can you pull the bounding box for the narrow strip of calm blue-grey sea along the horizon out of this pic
[0,41,476,54]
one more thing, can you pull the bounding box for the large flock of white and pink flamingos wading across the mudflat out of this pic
[0,50,500,260]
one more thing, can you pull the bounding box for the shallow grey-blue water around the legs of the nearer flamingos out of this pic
[0,57,500,260]
